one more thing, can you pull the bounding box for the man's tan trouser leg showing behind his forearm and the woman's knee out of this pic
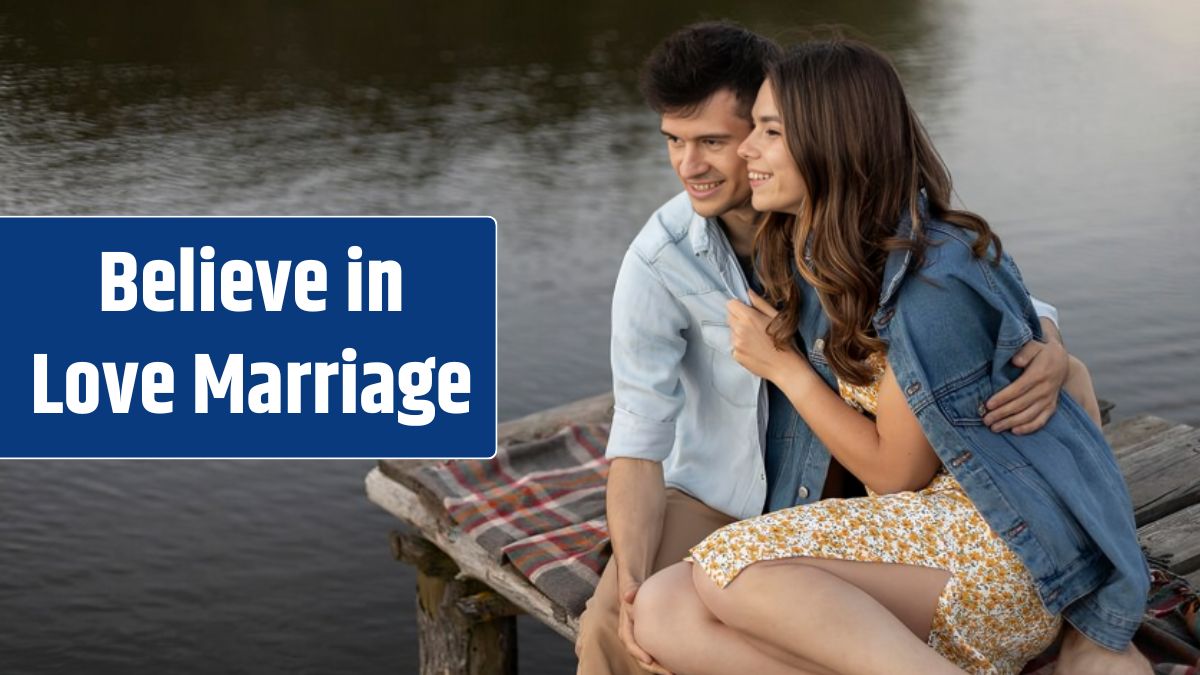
[575,489,736,675]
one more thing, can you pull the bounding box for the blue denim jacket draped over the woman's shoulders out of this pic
[799,199,1150,650]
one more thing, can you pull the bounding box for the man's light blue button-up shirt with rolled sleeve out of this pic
[606,192,767,518]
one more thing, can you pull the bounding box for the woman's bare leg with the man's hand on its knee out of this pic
[634,562,833,675]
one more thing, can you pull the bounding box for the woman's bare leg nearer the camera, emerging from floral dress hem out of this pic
[692,557,962,675]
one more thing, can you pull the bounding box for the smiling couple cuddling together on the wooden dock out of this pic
[576,24,1150,675]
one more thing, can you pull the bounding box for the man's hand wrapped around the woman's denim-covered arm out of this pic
[983,321,1069,435]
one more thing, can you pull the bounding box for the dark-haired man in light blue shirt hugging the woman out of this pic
[576,23,1098,675]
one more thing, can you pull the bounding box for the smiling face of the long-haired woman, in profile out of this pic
[738,80,808,214]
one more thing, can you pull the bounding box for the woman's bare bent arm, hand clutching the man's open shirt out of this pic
[727,292,941,495]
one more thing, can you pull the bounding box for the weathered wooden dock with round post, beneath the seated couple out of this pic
[366,394,1200,675]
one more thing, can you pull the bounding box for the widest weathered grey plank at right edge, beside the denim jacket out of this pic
[1117,425,1200,526]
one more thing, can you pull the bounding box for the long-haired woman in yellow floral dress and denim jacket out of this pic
[635,41,1148,675]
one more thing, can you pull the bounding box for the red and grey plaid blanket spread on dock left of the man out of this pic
[414,424,610,615]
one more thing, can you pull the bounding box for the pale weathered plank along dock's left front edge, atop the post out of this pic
[366,468,578,641]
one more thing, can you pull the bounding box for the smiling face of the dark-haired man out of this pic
[661,89,751,217]
